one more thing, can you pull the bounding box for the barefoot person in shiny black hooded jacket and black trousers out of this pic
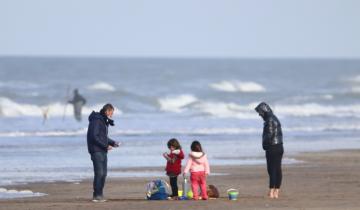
[255,102,284,198]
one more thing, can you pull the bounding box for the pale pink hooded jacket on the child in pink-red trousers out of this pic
[184,152,210,174]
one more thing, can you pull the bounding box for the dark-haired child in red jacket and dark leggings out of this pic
[163,138,184,200]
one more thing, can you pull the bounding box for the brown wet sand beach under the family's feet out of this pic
[0,150,360,210]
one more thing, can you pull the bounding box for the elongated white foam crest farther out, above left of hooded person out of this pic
[210,81,266,92]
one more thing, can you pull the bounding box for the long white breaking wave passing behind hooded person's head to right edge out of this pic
[159,94,360,119]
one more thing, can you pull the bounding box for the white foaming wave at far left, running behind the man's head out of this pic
[0,98,122,117]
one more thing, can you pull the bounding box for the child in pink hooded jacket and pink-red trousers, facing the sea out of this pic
[183,141,210,200]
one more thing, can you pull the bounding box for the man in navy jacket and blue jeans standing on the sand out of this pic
[87,104,119,202]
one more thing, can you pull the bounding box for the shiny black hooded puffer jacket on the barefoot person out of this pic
[255,103,283,150]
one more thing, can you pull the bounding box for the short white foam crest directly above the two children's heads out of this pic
[158,94,198,112]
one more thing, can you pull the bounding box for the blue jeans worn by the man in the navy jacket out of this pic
[91,152,107,197]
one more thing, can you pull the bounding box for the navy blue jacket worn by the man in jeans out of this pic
[87,111,116,154]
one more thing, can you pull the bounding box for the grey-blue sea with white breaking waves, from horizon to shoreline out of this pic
[0,57,360,199]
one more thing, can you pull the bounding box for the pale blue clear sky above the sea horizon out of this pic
[0,0,360,58]
